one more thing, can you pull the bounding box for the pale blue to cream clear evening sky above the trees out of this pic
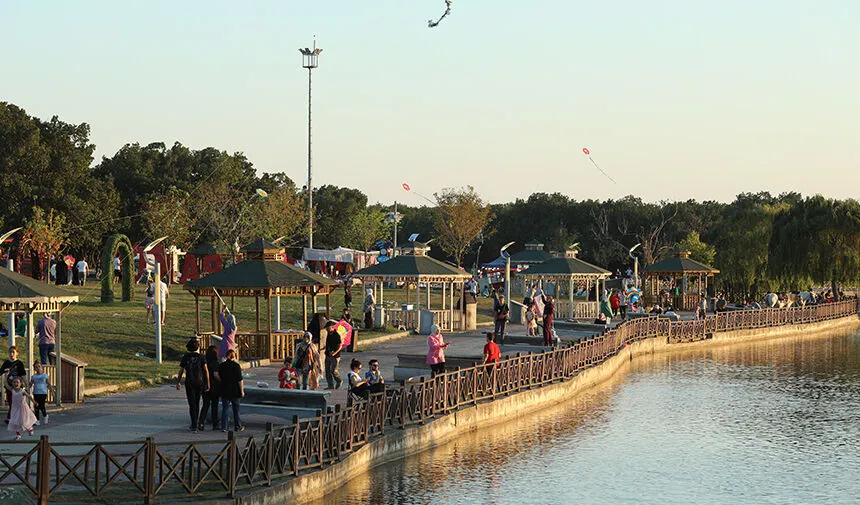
[0,0,860,205]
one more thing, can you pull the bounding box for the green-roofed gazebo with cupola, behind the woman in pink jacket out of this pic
[353,242,472,332]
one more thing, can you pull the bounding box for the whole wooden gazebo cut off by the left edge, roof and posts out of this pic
[0,268,80,406]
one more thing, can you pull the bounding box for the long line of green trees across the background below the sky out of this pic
[0,102,860,298]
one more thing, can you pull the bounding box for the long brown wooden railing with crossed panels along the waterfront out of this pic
[0,300,858,504]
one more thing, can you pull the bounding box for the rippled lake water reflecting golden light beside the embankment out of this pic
[314,326,860,505]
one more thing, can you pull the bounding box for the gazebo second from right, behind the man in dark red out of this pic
[519,249,611,319]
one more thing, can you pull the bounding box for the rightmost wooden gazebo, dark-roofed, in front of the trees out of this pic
[642,250,720,310]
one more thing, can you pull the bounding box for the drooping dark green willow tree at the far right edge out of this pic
[768,195,860,294]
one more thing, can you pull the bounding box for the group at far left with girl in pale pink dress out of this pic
[0,345,52,440]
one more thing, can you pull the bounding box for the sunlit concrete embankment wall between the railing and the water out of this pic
[236,316,860,505]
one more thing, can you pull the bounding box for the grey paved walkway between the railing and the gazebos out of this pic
[0,326,600,444]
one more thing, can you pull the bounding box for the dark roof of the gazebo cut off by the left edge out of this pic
[0,268,78,312]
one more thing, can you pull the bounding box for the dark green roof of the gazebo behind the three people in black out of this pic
[185,260,337,296]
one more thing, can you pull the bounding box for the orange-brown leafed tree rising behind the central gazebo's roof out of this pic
[434,186,493,267]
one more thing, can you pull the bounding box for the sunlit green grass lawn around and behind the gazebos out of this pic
[42,282,492,387]
